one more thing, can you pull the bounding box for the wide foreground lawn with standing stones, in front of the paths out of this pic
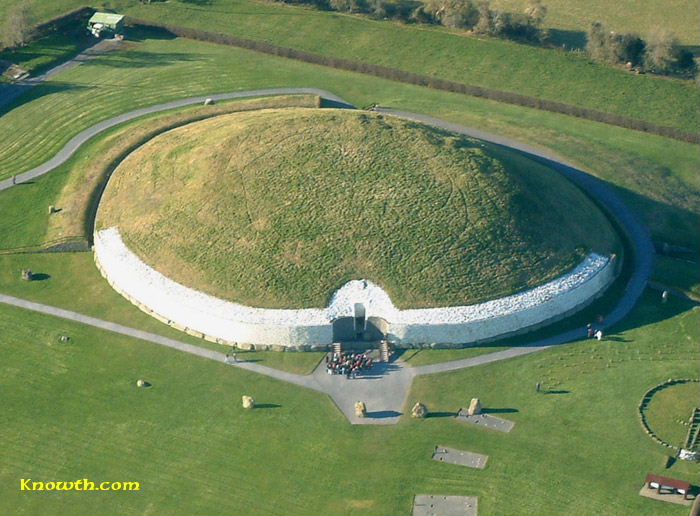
[0,292,699,516]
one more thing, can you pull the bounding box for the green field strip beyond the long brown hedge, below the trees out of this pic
[121,0,700,131]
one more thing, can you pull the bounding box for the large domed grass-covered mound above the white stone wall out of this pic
[99,109,616,308]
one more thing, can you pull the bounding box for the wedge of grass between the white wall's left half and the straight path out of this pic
[0,253,323,374]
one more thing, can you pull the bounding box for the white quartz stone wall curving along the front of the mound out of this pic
[95,228,616,349]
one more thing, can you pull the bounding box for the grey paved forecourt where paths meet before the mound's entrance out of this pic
[313,360,414,425]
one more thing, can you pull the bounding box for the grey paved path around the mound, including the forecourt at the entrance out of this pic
[0,88,654,424]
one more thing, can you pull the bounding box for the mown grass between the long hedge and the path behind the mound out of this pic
[0,33,700,247]
